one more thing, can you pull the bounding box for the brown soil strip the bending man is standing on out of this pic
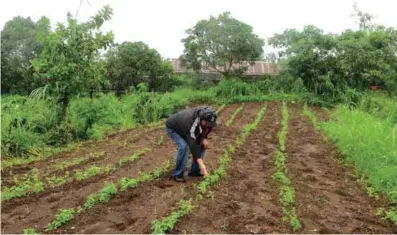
[52,104,261,233]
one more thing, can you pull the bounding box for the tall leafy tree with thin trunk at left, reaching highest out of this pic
[31,6,113,118]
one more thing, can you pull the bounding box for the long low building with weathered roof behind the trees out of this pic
[172,59,279,76]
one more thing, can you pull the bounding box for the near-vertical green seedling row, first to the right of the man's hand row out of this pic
[273,102,302,231]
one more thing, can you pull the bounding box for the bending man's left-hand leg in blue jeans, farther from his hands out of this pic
[167,128,188,178]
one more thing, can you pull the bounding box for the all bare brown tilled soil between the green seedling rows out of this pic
[1,102,397,234]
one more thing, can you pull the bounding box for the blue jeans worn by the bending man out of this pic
[166,127,205,177]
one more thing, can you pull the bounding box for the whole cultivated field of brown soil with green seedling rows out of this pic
[1,101,397,234]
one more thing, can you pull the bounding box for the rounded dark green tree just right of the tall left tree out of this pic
[106,42,173,94]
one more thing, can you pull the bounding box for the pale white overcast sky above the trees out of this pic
[0,0,397,58]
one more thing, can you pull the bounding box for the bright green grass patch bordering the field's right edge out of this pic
[321,106,397,202]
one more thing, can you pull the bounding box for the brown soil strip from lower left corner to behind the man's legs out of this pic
[1,105,238,233]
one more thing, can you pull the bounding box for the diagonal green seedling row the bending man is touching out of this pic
[152,105,266,234]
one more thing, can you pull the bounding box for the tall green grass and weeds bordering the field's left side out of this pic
[1,85,214,156]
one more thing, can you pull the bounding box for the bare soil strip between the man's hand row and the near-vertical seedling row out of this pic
[173,102,289,234]
